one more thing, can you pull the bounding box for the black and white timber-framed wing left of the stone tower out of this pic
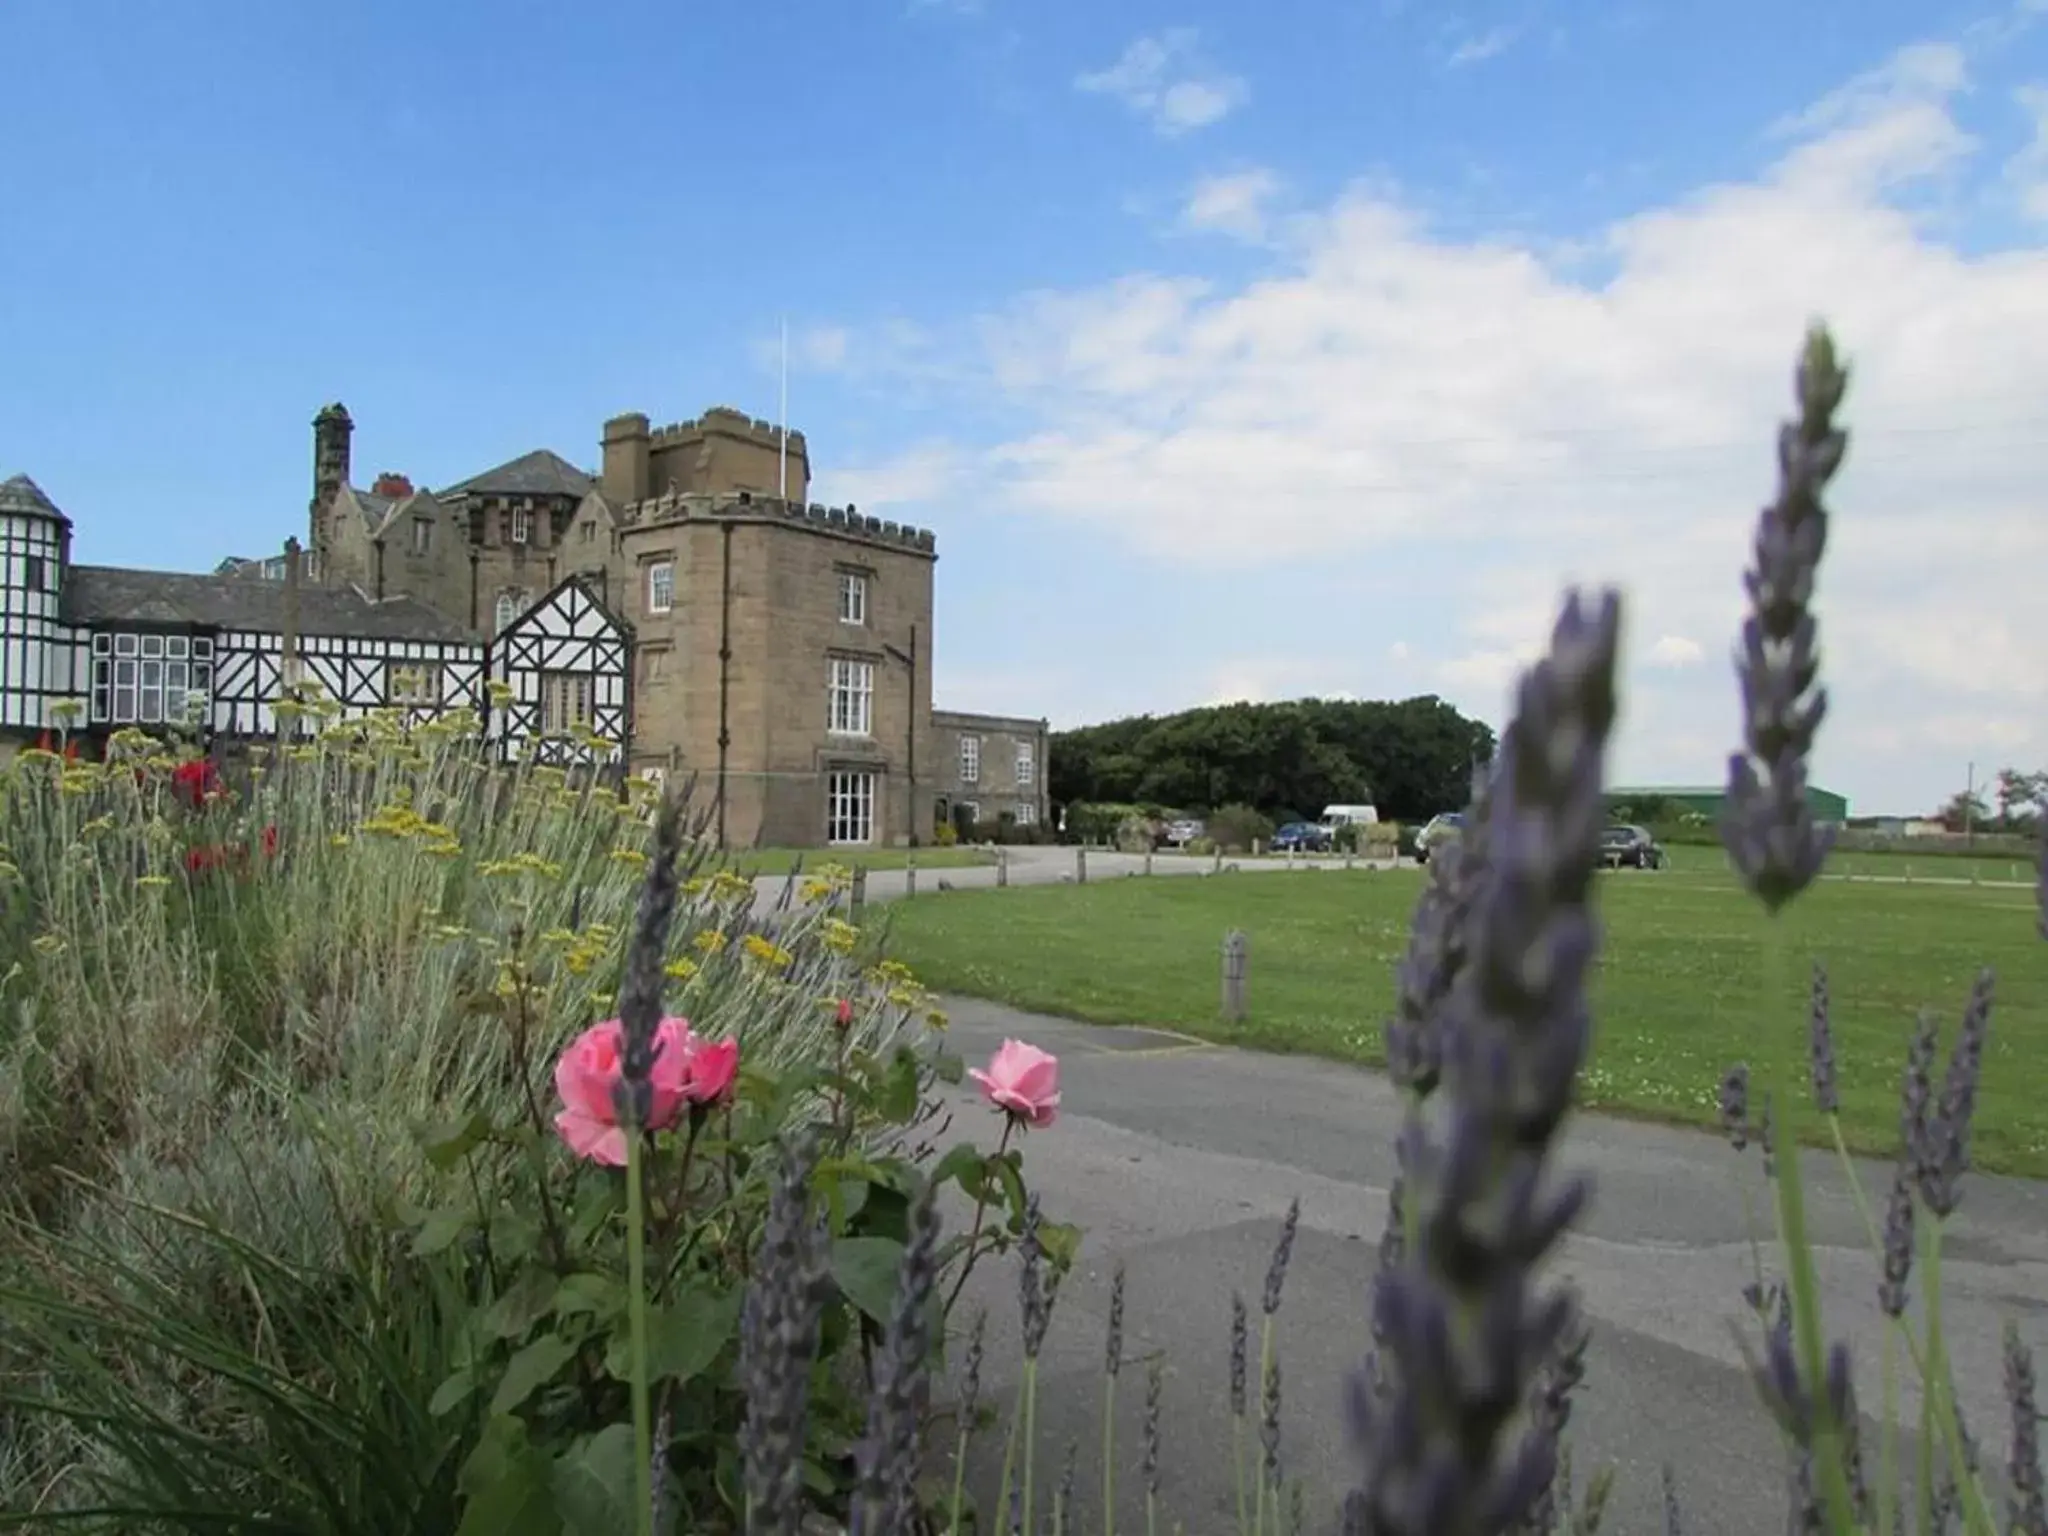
[0,475,631,764]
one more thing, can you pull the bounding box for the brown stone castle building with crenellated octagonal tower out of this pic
[203,403,1047,846]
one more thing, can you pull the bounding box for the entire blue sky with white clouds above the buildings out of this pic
[0,0,2048,811]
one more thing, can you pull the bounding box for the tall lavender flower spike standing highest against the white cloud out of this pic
[1720,328,1849,911]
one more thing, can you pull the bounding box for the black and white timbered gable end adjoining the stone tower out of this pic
[489,575,633,766]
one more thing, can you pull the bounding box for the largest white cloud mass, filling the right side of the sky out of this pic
[835,30,2048,809]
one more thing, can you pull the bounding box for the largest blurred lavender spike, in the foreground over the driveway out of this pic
[1346,592,1620,1536]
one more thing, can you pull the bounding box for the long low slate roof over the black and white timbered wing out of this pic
[63,565,473,641]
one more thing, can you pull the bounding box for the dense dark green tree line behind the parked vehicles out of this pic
[1049,694,1493,821]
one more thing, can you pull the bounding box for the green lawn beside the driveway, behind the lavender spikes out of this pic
[889,868,2048,1176]
